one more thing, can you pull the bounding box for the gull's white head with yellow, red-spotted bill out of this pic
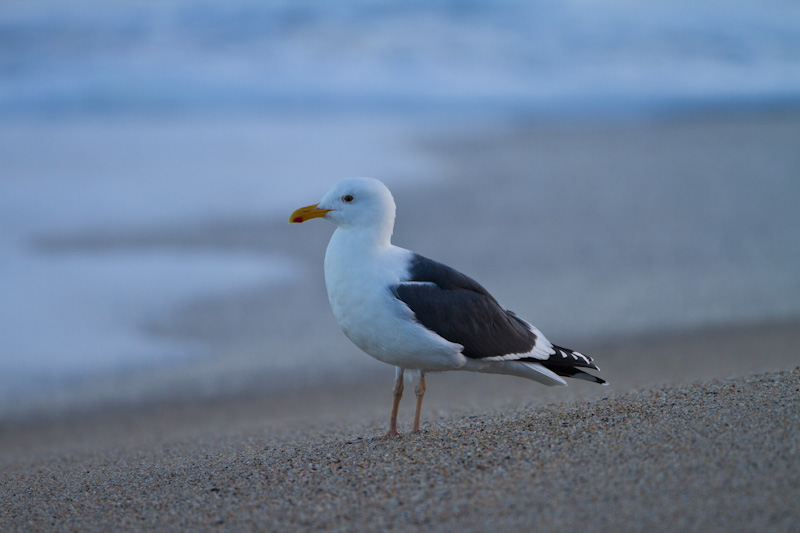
[289,178,395,234]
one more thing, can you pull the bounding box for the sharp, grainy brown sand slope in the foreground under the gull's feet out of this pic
[0,368,800,531]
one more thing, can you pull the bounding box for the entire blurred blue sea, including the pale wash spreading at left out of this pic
[0,0,800,408]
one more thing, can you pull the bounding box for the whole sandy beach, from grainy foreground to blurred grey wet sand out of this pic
[0,113,800,531]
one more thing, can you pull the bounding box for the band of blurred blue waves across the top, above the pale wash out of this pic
[0,0,800,117]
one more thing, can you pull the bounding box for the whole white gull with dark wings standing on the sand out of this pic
[289,178,607,437]
